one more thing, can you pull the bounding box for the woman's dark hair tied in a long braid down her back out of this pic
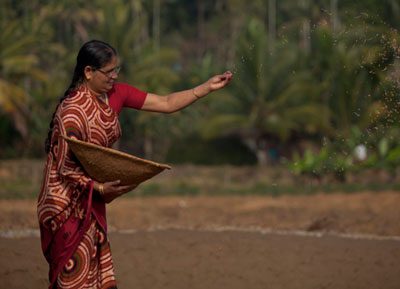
[44,40,117,153]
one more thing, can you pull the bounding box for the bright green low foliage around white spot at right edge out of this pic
[288,127,400,181]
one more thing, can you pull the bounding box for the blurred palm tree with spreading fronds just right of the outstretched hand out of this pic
[198,20,329,165]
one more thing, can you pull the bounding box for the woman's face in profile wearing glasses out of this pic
[85,56,119,94]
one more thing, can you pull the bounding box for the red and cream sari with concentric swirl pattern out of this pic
[38,86,121,288]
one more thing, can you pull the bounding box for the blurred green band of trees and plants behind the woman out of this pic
[0,0,400,196]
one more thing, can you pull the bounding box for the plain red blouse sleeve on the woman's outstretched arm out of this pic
[107,83,147,114]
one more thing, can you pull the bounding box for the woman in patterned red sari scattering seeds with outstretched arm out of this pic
[38,40,232,288]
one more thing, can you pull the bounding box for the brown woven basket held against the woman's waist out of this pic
[64,136,171,185]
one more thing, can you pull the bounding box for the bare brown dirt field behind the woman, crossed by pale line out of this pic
[0,192,400,289]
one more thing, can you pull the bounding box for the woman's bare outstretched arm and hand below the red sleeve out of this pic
[142,71,232,113]
